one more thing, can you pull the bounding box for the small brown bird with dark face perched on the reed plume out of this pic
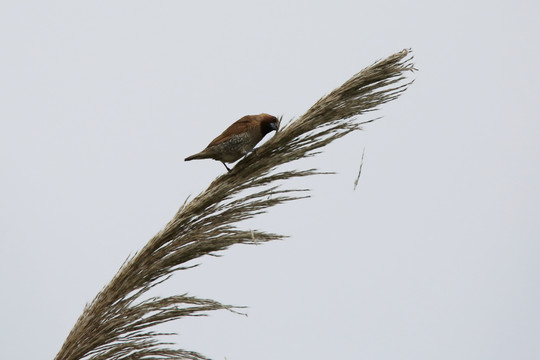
[185,113,279,171]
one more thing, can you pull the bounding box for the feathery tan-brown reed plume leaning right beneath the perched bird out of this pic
[55,50,414,360]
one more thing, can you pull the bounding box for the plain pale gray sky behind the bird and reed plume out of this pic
[0,0,540,360]
